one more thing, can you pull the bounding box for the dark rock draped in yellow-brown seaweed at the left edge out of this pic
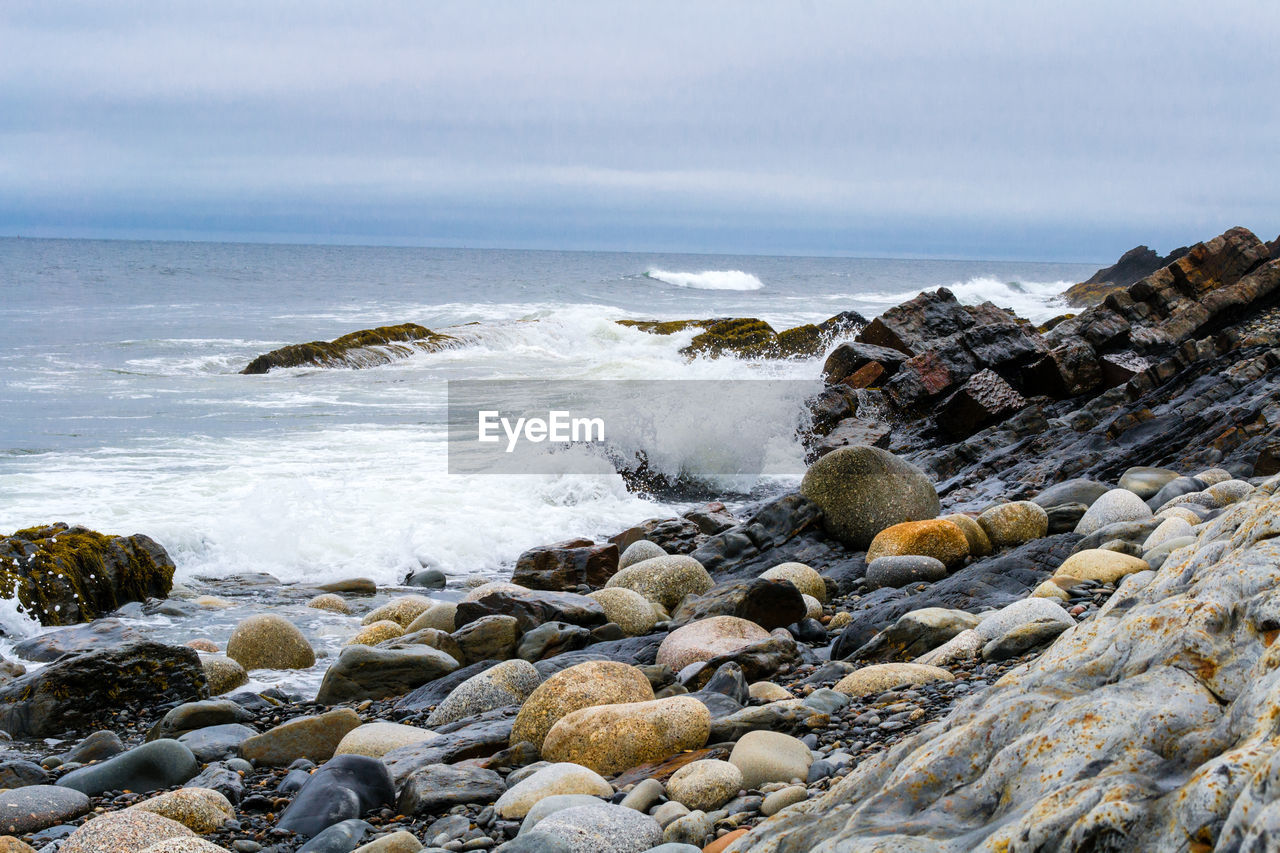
[0,523,174,631]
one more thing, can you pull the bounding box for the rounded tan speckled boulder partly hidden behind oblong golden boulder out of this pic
[511,661,653,749]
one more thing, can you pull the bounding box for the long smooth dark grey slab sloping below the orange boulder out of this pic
[831,533,1080,660]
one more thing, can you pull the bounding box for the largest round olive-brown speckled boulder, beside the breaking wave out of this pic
[800,447,938,549]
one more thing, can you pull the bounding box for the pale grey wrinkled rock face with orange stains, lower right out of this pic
[733,478,1280,853]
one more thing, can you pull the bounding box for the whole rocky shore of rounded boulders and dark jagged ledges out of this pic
[0,229,1280,853]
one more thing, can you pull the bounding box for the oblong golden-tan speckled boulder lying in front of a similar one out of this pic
[541,695,710,774]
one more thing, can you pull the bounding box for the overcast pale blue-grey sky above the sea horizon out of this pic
[0,0,1280,263]
